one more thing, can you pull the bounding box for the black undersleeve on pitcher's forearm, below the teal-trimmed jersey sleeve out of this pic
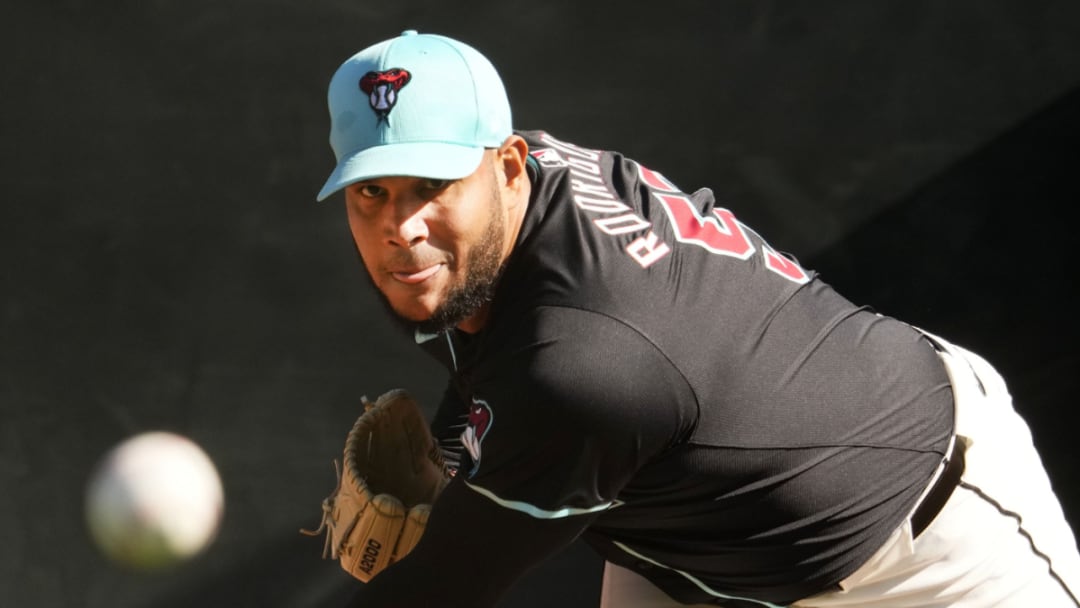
[348,476,596,608]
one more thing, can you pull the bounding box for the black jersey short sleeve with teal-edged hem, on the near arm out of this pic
[459,307,697,519]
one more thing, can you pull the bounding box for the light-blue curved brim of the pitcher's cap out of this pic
[316,143,484,201]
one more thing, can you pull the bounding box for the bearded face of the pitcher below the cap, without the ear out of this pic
[346,151,507,332]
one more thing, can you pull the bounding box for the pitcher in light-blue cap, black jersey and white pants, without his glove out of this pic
[304,31,1080,608]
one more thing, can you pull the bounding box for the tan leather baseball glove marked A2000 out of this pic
[300,389,449,582]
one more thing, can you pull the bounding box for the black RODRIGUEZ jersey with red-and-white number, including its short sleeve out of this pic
[418,132,953,605]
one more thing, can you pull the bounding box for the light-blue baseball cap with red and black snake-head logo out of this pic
[318,29,512,201]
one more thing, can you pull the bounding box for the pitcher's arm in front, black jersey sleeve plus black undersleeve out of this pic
[350,309,693,608]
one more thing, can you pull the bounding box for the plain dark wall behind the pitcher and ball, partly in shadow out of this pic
[0,0,1080,608]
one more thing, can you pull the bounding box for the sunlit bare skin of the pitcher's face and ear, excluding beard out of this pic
[345,135,530,333]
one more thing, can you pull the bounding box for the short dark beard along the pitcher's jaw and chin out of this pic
[357,189,505,337]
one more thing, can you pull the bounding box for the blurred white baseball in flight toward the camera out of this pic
[85,431,225,570]
